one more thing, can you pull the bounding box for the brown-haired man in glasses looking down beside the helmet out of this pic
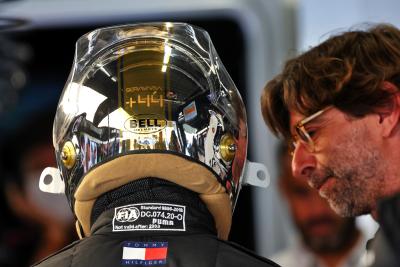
[261,24,400,266]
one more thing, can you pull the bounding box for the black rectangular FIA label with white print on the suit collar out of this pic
[113,203,186,232]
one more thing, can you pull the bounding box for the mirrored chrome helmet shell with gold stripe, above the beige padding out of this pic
[53,23,253,209]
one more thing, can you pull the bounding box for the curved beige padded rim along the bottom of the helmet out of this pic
[74,153,232,240]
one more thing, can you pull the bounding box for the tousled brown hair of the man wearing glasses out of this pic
[261,24,400,138]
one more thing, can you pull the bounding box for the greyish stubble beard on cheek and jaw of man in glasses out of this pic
[316,126,385,217]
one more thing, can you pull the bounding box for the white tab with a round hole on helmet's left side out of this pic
[39,167,65,194]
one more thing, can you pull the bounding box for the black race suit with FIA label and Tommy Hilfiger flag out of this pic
[35,178,278,267]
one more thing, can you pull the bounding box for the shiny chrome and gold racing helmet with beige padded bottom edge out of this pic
[40,22,267,239]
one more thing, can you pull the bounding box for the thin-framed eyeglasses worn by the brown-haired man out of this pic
[289,106,333,155]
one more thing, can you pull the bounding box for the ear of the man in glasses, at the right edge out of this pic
[378,81,400,137]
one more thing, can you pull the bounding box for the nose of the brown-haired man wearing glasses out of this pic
[292,142,316,179]
